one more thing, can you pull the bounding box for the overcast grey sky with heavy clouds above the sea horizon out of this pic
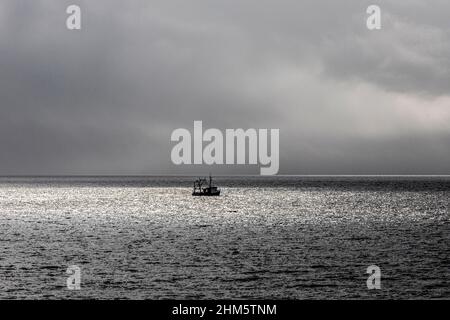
[0,0,450,175]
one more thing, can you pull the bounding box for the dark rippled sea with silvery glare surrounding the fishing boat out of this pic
[0,176,450,299]
